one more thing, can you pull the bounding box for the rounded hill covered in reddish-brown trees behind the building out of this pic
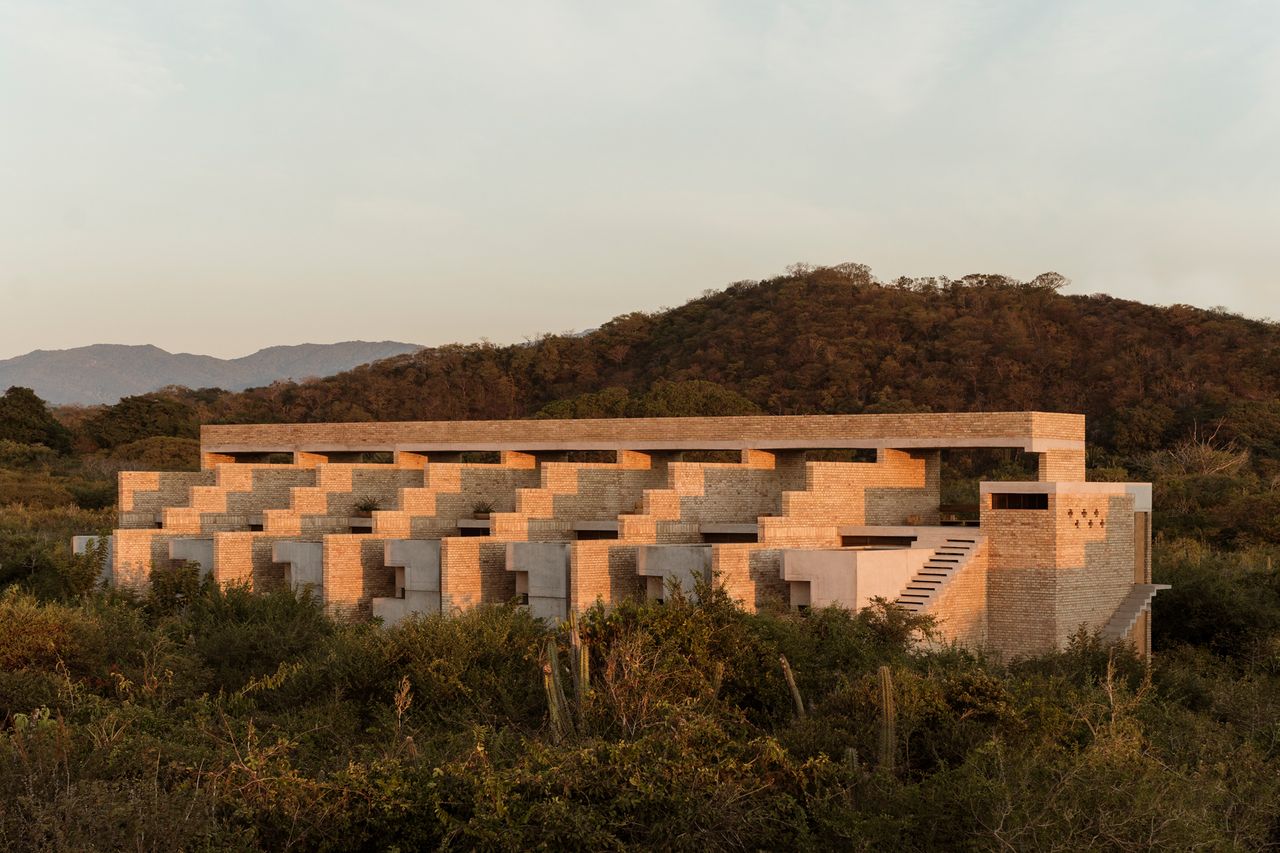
[194,264,1280,451]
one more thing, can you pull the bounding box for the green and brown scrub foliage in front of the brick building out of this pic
[0,546,1280,850]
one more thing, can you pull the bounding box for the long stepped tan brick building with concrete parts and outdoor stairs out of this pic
[94,412,1157,654]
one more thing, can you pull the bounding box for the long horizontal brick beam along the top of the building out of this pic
[200,411,1084,453]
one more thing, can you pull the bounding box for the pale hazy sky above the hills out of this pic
[0,0,1280,359]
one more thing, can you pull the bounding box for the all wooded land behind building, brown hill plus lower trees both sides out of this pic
[0,265,1280,547]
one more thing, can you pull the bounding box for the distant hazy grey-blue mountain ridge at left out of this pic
[0,341,421,405]
